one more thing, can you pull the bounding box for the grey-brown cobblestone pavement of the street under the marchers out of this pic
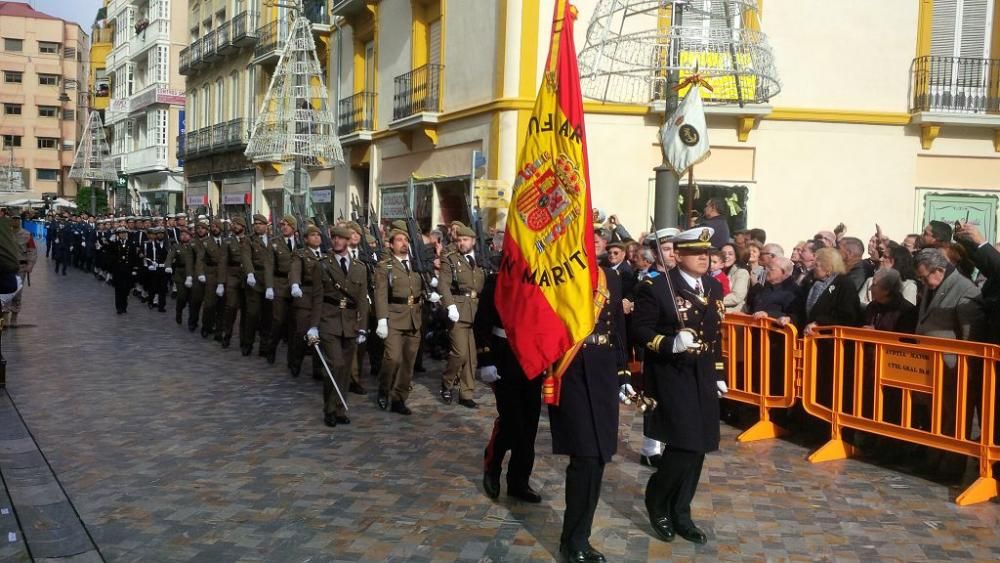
[0,261,1000,562]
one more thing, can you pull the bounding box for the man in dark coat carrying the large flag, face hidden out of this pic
[549,268,628,561]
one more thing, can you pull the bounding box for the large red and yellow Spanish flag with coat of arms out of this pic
[496,0,598,384]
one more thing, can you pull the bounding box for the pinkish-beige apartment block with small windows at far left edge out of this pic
[0,2,90,200]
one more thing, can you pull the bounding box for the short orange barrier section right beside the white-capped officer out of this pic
[722,313,801,442]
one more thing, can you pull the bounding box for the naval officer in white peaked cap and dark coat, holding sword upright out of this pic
[632,227,727,543]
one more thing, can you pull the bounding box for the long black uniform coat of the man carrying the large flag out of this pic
[549,268,626,463]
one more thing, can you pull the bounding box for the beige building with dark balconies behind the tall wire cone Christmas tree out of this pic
[177,0,333,220]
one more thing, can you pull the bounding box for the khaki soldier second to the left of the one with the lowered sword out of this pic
[261,215,302,367]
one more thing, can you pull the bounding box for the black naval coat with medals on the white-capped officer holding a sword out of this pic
[632,268,725,453]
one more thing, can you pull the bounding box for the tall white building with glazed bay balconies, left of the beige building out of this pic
[105,0,188,213]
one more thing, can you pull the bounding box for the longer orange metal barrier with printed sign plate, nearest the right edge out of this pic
[800,326,1000,505]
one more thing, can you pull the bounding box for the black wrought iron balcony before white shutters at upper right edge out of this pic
[910,56,1000,114]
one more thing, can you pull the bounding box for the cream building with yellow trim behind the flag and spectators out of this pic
[331,0,1000,245]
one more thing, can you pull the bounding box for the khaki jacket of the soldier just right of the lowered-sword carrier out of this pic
[375,256,424,330]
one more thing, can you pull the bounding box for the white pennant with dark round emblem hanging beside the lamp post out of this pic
[660,81,711,176]
